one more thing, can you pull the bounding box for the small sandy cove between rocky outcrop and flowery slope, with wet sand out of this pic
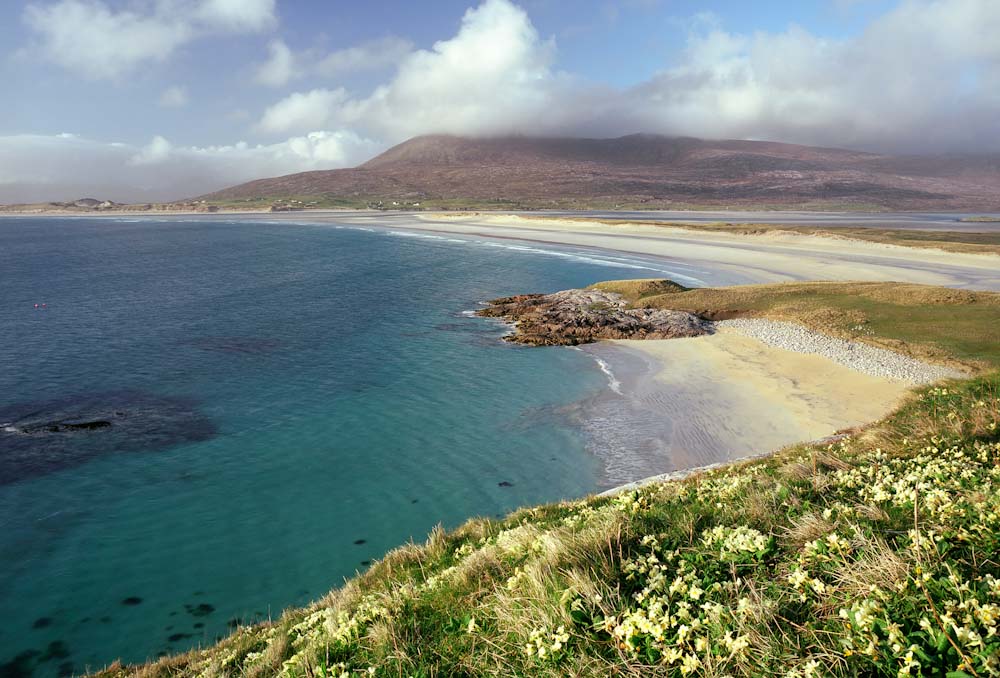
[578,322,944,495]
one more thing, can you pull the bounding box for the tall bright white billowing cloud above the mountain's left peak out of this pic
[259,0,561,141]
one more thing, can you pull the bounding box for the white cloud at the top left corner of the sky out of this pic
[24,0,277,79]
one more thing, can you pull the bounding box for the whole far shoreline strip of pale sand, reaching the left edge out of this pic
[7,210,1000,291]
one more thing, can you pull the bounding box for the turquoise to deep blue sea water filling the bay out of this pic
[0,219,708,676]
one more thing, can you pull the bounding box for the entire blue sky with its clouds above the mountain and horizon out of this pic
[0,0,1000,202]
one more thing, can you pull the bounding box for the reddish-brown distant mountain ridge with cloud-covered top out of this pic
[201,134,1000,210]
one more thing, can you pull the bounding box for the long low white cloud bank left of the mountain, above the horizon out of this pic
[0,130,381,202]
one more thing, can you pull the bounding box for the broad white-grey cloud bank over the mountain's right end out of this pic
[612,0,1000,150]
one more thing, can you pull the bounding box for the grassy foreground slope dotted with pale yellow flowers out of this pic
[95,281,1000,678]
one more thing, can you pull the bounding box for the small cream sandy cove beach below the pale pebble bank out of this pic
[593,329,910,484]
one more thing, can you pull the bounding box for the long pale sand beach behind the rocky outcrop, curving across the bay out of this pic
[413,214,1000,290]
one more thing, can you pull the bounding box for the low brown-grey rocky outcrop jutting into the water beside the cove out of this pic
[477,289,712,346]
